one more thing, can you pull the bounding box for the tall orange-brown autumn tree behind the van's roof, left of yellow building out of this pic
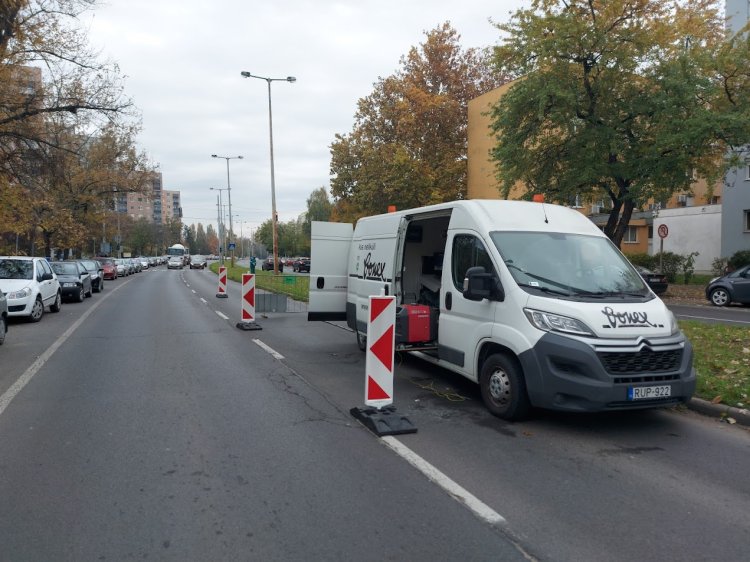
[331,23,501,220]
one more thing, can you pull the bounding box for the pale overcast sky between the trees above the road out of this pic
[88,0,524,234]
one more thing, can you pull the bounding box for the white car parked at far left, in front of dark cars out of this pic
[0,256,62,322]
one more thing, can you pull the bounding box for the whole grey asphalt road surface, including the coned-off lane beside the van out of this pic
[0,269,750,561]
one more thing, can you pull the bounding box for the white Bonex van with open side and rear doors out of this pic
[308,200,695,420]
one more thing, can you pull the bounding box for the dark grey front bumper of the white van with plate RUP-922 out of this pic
[519,332,695,412]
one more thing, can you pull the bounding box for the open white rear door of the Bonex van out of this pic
[307,221,354,320]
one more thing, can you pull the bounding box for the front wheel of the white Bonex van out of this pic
[479,353,531,421]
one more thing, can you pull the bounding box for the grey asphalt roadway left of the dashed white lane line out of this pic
[0,268,524,560]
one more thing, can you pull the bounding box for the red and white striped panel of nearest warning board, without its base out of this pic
[365,296,396,408]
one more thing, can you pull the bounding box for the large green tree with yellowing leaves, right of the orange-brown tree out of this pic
[492,0,750,245]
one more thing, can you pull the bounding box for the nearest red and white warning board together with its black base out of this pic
[350,295,417,436]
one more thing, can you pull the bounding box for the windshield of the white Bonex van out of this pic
[490,231,649,297]
